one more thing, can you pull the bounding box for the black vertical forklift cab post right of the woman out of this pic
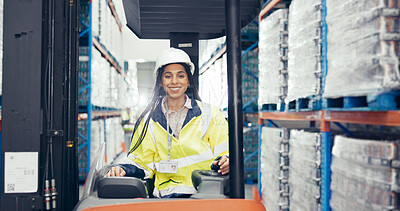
[225,0,244,198]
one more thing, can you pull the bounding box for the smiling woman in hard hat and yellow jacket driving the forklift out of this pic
[106,48,229,198]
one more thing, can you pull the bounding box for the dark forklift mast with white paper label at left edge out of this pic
[0,0,79,211]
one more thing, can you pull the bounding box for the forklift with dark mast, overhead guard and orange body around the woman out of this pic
[0,0,265,211]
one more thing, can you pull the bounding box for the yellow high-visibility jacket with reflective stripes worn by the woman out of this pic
[123,99,229,197]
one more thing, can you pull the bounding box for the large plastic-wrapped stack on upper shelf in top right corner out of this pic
[324,0,400,97]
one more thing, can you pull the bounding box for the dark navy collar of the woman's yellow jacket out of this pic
[151,96,201,131]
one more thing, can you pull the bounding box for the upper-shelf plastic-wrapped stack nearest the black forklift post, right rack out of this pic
[258,9,288,106]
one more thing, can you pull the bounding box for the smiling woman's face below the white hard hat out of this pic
[161,64,190,99]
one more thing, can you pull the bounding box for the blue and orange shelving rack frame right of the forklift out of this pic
[258,0,400,211]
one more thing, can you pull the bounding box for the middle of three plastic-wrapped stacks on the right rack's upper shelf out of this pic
[285,0,322,103]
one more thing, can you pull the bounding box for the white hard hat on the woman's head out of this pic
[154,48,194,78]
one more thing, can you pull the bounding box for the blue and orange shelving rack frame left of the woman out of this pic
[78,0,126,182]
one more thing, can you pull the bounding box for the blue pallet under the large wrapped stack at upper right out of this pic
[322,91,400,111]
